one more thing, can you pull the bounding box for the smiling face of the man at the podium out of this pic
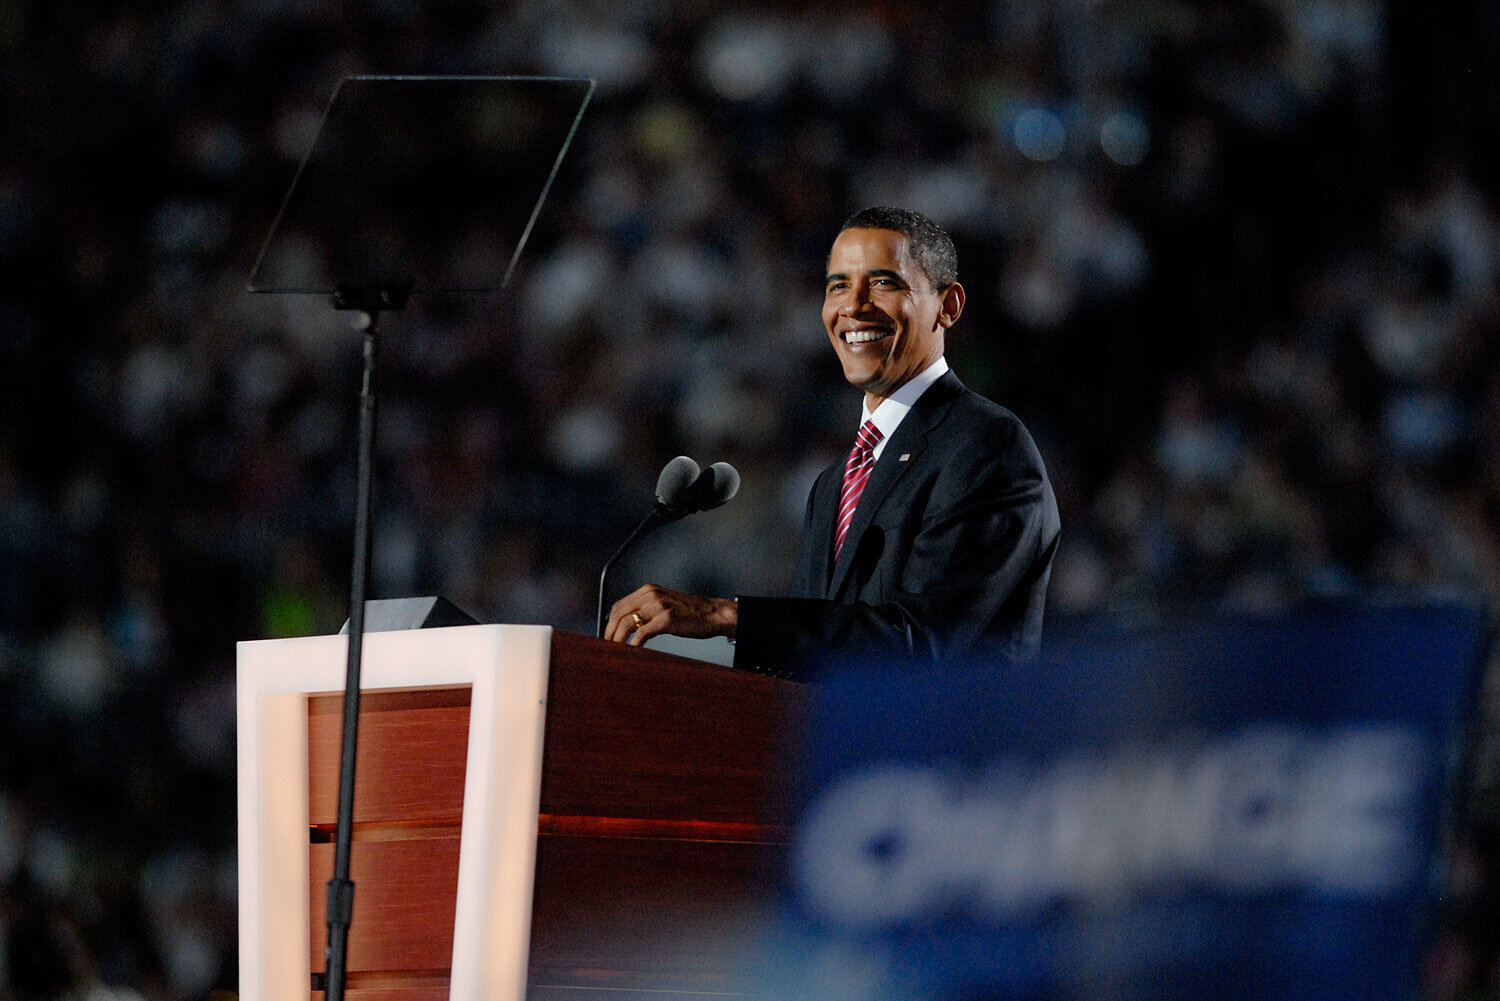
[824,228,963,410]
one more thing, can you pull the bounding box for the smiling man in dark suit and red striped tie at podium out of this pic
[605,207,1059,678]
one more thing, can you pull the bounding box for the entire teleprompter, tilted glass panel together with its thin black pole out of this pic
[249,75,594,1001]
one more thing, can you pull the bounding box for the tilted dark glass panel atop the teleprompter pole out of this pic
[251,77,594,294]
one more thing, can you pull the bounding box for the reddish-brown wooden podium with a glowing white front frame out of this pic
[239,626,800,1001]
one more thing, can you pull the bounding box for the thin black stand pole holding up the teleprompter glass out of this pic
[324,279,411,1001]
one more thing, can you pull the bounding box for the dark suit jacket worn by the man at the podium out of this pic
[735,372,1061,678]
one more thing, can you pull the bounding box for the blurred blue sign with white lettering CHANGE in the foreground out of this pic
[765,606,1487,1001]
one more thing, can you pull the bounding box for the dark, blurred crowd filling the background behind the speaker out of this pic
[0,0,1500,1001]
